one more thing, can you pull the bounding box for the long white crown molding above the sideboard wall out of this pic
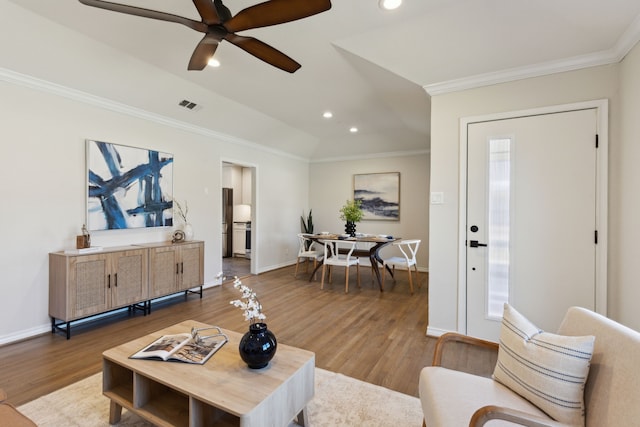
[0,67,309,162]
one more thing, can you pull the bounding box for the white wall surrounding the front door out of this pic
[429,63,628,331]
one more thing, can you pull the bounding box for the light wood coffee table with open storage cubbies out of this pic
[102,320,315,427]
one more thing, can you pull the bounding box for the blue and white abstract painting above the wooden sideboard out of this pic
[87,140,173,230]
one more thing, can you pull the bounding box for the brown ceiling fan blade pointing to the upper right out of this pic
[224,0,331,33]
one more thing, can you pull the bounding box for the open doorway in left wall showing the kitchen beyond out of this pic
[221,161,256,278]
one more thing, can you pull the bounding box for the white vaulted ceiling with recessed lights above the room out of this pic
[3,0,640,161]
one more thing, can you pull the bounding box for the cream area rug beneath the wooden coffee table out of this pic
[19,368,422,427]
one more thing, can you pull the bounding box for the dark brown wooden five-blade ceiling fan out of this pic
[79,0,331,73]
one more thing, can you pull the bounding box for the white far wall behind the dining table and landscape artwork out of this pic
[308,153,430,271]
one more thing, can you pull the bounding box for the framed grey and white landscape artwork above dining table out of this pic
[353,172,400,221]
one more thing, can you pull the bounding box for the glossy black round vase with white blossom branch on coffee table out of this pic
[231,277,278,369]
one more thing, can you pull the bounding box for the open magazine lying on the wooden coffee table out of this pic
[130,327,229,365]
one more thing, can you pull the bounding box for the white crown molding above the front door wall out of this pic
[422,15,640,96]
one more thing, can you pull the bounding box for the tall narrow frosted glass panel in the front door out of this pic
[486,138,511,319]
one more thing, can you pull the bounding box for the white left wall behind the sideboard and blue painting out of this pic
[0,76,308,342]
